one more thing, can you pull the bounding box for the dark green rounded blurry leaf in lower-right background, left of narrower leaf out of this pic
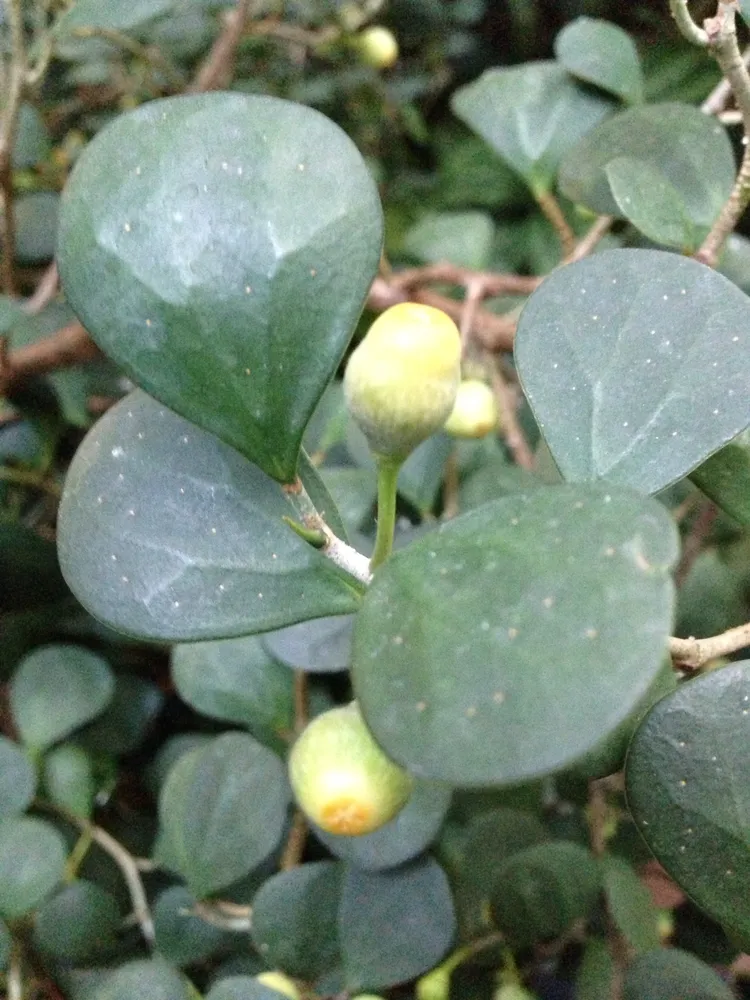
[491,840,601,947]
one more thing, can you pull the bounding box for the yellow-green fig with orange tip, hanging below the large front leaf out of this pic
[289,702,412,836]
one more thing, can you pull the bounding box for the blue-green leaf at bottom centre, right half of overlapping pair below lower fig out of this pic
[339,858,456,993]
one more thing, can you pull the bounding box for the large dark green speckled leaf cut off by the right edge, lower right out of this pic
[626,660,750,934]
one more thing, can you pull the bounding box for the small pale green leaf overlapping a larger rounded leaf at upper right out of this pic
[605,156,706,253]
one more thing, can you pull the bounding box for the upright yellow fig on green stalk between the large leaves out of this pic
[344,302,461,462]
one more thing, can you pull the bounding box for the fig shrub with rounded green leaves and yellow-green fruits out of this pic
[5,0,750,1000]
